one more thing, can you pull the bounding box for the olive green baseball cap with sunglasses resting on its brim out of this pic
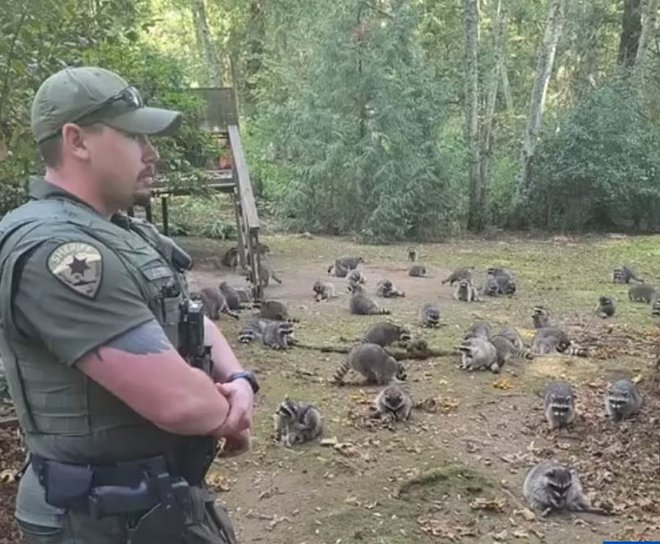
[32,66,181,142]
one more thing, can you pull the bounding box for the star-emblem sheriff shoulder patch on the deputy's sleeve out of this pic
[48,242,103,298]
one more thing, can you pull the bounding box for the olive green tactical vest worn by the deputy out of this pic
[0,197,187,464]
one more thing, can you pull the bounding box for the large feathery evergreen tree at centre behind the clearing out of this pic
[250,1,459,242]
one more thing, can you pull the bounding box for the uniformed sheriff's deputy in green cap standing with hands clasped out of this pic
[0,67,258,544]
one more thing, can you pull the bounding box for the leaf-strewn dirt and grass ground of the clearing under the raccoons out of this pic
[0,235,660,544]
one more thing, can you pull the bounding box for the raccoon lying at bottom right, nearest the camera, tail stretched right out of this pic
[523,461,607,517]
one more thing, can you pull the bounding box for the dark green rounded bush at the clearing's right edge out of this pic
[529,78,660,229]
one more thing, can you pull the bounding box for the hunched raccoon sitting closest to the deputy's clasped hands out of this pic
[273,397,323,446]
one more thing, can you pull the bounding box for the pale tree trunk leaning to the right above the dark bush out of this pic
[514,0,564,221]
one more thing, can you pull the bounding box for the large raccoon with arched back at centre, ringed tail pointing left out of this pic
[333,344,407,385]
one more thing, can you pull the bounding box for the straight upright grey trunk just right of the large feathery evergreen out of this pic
[464,0,484,230]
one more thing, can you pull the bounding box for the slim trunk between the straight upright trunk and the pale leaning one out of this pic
[479,0,506,202]
